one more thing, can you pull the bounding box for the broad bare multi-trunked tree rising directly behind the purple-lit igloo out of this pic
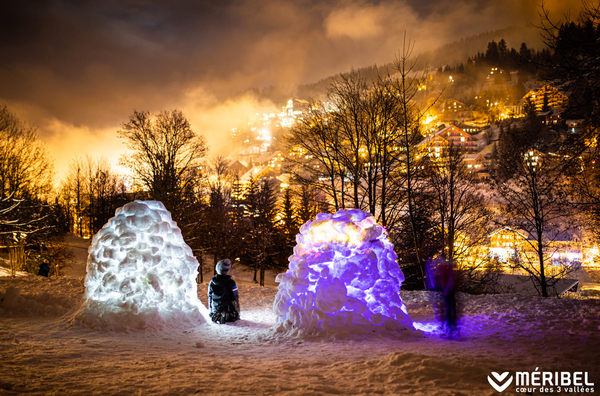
[288,71,412,226]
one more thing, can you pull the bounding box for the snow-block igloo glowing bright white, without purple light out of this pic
[74,201,207,330]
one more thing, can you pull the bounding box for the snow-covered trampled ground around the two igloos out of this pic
[0,273,600,395]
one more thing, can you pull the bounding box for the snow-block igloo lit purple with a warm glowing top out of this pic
[273,209,414,335]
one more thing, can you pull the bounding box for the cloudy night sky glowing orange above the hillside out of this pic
[0,0,580,178]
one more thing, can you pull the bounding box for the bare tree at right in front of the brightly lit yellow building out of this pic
[492,140,576,297]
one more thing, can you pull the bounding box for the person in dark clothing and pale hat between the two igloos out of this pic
[208,259,240,324]
